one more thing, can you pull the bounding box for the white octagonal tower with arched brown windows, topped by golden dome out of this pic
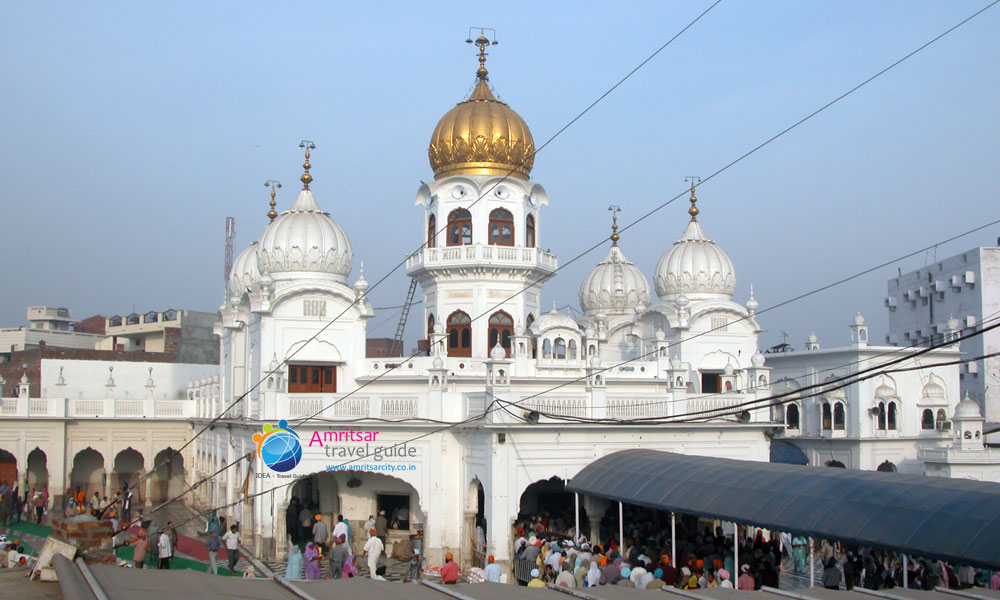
[406,33,557,358]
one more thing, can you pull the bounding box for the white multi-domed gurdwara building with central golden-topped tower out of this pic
[196,36,773,569]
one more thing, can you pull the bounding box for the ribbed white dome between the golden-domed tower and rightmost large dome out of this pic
[580,244,651,314]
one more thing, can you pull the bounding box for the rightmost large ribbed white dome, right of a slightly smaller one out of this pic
[654,219,736,300]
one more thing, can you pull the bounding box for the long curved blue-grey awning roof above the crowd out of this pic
[566,450,1000,568]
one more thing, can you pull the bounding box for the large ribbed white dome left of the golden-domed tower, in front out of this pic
[257,190,354,284]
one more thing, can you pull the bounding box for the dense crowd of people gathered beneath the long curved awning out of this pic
[508,507,1000,590]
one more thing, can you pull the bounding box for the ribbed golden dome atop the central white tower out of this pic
[427,75,535,179]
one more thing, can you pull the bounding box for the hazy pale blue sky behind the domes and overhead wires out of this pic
[0,0,1000,348]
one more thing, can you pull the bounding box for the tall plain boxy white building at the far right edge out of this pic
[885,246,1000,423]
